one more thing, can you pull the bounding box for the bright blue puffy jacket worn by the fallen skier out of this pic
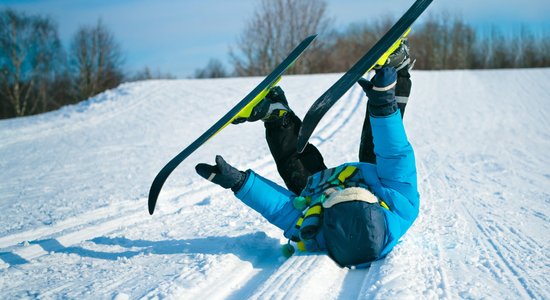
[236,110,419,257]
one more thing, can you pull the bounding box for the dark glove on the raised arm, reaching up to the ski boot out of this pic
[357,67,397,117]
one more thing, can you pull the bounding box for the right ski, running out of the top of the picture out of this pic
[296,0,433,153]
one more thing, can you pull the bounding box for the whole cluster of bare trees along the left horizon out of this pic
[0,9,173,119]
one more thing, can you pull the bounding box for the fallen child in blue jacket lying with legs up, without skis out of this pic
[196,41,419,268]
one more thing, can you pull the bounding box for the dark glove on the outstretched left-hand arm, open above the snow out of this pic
[195,155,246,192]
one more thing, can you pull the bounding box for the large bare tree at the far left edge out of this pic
[0,9,62,116]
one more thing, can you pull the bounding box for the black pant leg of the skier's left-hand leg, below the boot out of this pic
[265,112,327,195]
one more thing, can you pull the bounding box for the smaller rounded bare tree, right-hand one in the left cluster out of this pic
[70,20,123,100]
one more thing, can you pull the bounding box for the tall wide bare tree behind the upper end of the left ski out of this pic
[230,0,329,76]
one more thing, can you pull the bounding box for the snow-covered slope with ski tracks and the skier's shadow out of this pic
[0,69,550,299]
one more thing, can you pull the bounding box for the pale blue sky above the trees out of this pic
[0,0,550,78]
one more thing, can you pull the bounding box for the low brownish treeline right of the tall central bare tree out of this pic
[326,16,550,72]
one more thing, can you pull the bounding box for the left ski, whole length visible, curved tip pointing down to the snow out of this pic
[149,35,317,215]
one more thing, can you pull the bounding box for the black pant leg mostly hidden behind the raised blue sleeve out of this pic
[359,68,412,164]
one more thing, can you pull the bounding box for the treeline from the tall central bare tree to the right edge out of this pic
[195,0,550,78]
